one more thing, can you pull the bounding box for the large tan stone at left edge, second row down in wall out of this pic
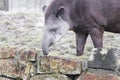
[0,60,31,79]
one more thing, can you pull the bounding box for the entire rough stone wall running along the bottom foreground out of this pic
[0,47,120,80]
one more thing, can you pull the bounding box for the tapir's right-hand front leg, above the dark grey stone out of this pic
[90,28,104,48]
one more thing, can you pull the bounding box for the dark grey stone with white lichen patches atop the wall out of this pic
[88,49,117,70]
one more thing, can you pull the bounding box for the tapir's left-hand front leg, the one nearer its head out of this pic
[76,32,88,56]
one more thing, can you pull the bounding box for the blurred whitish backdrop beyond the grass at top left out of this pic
[0,0,51,12]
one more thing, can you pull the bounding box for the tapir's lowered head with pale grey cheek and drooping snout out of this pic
[42,6,69,55]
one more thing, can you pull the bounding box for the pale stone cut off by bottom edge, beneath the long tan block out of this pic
[30,74,70,80]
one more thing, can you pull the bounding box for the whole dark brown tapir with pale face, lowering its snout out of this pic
[42,0,120,56]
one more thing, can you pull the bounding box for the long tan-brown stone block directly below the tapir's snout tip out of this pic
[37,56,81,75]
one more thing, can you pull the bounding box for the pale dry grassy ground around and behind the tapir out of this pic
[0,12,120,55]
